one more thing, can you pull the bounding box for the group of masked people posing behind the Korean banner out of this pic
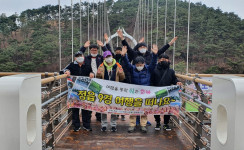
[60,30,181,133]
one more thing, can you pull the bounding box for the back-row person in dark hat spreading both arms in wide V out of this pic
[117,30,178,65]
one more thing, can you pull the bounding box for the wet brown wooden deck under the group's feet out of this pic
[55,114,192,150]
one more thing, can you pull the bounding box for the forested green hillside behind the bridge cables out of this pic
[0,0,244,73]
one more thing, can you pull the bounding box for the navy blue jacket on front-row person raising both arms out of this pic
[122,54,157,85]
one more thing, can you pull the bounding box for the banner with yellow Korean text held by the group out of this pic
[67,76,181,116]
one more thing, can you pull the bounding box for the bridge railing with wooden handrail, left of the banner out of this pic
[41,74,68,150]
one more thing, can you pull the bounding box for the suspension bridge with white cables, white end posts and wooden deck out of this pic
[0,0,244,150]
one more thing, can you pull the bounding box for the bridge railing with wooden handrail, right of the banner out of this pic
[171,74,212,149]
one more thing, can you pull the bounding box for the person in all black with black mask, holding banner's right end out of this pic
[151,54,182,131]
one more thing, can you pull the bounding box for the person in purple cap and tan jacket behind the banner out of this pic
[96,51,125,132]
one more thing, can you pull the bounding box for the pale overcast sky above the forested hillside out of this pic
[0,0,244,19]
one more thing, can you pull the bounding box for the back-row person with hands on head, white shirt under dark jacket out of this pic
[80,40,107,122]
